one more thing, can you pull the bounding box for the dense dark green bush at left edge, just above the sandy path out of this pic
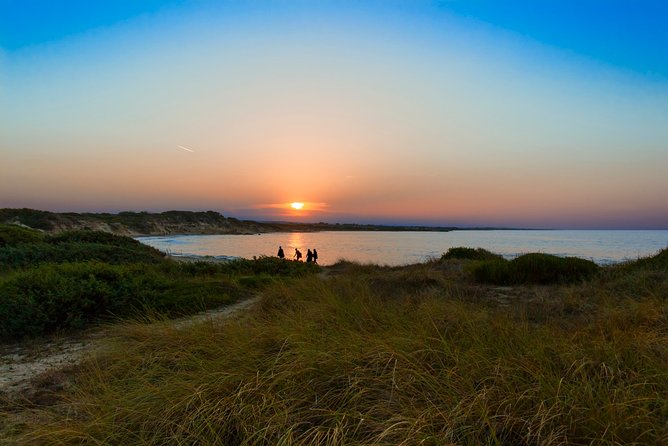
[0,262,175,338]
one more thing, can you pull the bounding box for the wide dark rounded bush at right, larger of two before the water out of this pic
[472,253,599,285]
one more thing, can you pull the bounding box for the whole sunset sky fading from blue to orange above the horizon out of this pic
[0,0,668,229]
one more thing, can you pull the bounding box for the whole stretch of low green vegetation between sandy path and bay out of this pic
[0,225,317,339]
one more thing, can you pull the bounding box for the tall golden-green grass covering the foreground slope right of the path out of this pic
[6,251,668,445]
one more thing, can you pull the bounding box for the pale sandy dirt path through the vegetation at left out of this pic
[0,297,259,396]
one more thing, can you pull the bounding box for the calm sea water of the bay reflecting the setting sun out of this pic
[139,230,668,265]
